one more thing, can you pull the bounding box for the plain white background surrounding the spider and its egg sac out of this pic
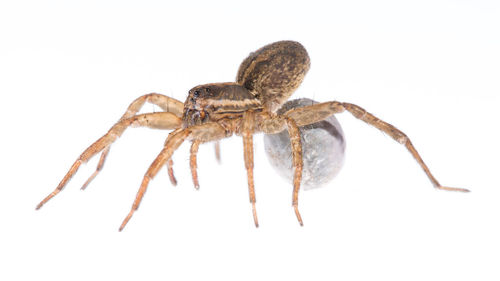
[0,0,500,280]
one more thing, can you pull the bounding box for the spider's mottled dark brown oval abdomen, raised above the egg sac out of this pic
[236,41,311,112]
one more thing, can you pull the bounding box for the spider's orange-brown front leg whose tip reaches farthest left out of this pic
[36,112,182,210]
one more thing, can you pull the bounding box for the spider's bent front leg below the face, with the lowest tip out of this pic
[119,123,228,231]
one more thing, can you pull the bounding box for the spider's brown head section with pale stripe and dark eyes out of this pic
[183,82,261,127]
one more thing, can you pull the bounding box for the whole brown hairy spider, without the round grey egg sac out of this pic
[36,41,469,231]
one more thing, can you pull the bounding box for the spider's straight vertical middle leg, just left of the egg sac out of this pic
[242,111,259,227]
